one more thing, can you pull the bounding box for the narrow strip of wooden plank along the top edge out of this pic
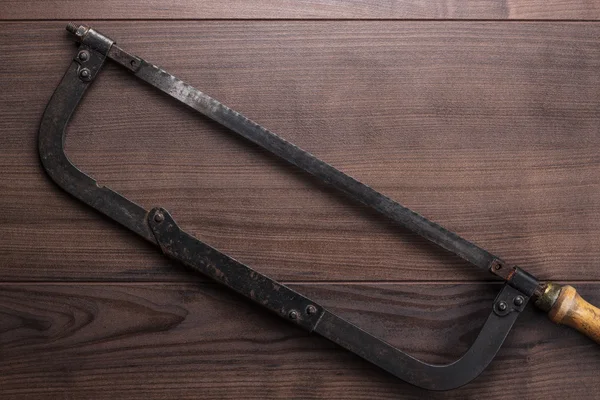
[0,0,600,20]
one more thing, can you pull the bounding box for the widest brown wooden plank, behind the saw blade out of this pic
[0,21,600,281]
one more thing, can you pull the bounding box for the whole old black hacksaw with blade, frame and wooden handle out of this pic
[39,24,600,390]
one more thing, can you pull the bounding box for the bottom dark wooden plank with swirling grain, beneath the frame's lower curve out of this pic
[0,284,600,400]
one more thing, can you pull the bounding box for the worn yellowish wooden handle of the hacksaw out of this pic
[542,284,600,344]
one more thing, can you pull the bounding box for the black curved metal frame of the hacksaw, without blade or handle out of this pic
[39,27,529,390]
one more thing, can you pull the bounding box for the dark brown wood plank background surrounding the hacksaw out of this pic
[0,0,600,399]
